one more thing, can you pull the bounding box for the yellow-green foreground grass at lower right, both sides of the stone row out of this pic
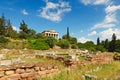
[42,61,120,80]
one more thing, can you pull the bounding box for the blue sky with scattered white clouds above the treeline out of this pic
[0,0,120,42]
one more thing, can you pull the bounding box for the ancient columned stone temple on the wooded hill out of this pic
[42,30,59,39]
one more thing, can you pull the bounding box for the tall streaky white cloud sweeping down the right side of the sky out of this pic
[92,5,120,29]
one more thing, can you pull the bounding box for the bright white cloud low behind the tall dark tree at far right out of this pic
[100,28,120,40]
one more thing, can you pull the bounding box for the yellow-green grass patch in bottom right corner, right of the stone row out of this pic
[91,61,120,79]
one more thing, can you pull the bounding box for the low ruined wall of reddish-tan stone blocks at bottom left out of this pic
[0,63,58,80]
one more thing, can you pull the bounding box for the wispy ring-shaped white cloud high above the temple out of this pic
[39,0,71,22]
